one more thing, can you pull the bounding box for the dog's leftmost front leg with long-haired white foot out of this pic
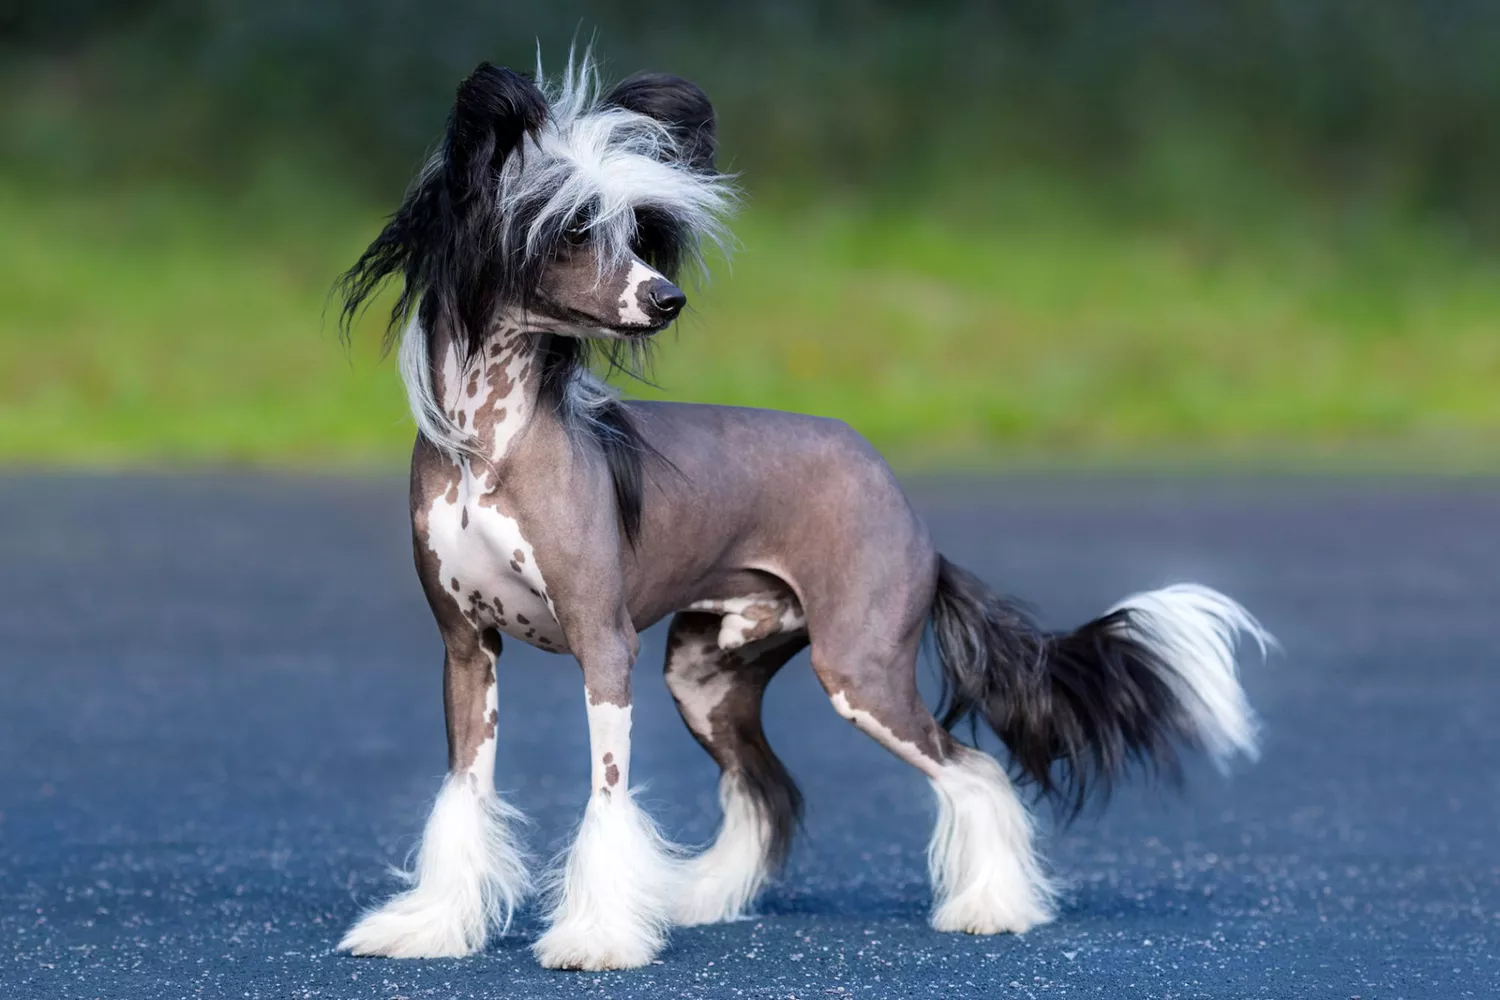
[339,627,528,958]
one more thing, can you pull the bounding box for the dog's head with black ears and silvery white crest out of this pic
[344,58,732,354]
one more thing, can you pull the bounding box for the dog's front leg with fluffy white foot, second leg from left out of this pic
[533,618,681,970]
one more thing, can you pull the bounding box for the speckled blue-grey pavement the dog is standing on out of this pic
[0,475,1500,1000]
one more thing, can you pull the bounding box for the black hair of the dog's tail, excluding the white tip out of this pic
[932,559,1200,819]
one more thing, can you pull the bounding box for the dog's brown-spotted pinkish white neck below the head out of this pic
[431,319,543,471]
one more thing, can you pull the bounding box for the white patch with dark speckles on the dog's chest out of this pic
[428,490,567,652]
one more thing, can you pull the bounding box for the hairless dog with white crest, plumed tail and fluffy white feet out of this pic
[339,55,1272,970]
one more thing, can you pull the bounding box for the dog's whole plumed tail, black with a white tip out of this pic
[932,559,1275,816]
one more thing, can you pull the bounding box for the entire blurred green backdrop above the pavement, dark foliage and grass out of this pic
[0,0,1500,469]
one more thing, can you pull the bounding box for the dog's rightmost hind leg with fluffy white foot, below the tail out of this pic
[813,609,1053,934]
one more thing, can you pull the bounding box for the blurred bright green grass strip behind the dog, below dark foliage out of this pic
[0,171,1500,468]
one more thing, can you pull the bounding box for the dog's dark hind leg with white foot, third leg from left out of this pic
[666,612,807,925]
